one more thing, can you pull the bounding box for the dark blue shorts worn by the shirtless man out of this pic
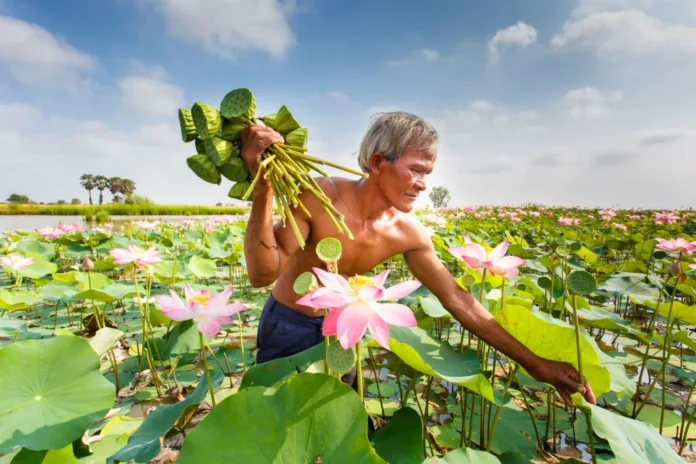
[256,294,324,364]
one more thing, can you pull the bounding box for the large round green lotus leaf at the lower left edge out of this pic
[0,337,115,453]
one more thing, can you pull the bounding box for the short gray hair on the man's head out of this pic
[358,111,439,172]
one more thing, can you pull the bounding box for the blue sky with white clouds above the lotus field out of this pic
[0,0,696,208]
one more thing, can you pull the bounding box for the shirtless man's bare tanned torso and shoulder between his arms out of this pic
[273,177,424,316]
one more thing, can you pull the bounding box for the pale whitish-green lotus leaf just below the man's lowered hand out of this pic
[572,393,684,464]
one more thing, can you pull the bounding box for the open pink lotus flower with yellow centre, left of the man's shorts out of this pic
[155,285,248,338]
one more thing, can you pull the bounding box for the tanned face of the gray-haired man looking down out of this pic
[371,150,436,213]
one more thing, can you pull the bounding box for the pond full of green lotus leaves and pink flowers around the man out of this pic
[0,206,696,464]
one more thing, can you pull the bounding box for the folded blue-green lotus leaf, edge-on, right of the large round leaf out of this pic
[106,370,224,464]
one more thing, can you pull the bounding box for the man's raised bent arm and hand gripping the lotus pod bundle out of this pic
[242,126,310,287]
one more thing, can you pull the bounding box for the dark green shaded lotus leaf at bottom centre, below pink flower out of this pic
[372,407,423,464]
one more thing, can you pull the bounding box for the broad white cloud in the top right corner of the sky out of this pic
[551,10,696,59]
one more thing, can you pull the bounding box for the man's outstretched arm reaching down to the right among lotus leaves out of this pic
[405,230,595,404]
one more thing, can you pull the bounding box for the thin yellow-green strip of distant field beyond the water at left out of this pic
[0,204,248,216]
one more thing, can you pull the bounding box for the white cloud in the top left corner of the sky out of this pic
[0,16,97,90]
